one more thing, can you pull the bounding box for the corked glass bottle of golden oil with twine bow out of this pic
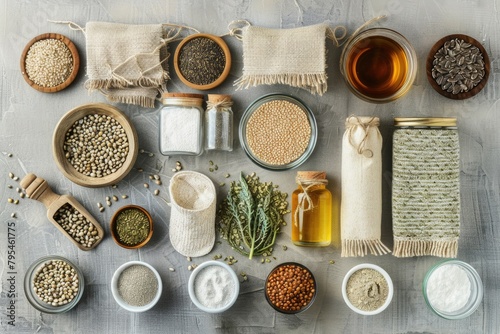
[292,171,333,247]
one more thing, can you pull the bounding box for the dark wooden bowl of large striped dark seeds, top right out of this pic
[426,34,490,100]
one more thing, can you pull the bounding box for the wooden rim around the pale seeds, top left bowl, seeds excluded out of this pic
[21,33,80,93]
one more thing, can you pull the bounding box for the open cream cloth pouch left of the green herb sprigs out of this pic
[169,171,216,257]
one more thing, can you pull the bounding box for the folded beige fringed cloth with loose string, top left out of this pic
[85,22,169,108]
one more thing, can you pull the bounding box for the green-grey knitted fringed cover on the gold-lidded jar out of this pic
[392,128,460,258]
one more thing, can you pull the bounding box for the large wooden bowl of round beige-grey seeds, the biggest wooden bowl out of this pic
[52,103,139,188]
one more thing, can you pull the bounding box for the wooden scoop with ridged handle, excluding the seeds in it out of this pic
[21,173,104,251]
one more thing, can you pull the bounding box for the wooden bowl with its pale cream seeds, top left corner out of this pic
[21,33,80,93]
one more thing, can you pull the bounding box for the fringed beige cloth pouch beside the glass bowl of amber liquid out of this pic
[232,22,346,95]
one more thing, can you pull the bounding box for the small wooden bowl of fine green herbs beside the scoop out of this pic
[110,205,153,249]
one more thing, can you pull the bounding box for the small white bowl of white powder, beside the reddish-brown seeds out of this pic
[188,261,240,313]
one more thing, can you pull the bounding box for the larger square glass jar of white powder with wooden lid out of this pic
[159,93,204,155]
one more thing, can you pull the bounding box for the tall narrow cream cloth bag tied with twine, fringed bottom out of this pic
[340,116,390,257]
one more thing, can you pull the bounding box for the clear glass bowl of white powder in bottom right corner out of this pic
[423,260,483,320]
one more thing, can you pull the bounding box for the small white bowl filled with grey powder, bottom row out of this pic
[111,261,163,312]
